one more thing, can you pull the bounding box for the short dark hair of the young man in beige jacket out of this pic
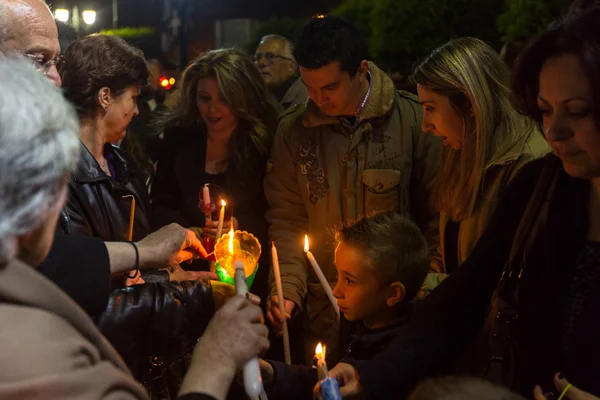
[294,16,368,77]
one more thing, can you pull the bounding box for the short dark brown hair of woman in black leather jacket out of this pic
[59,35,148,118]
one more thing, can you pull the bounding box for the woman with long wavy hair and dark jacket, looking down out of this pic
[151,49,279,302]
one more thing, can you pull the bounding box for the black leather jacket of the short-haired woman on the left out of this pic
[57,144,215,399]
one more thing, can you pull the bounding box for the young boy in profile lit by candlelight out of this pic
[261,212,430,400]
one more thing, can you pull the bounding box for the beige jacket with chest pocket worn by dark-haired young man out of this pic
[265,63,441,360]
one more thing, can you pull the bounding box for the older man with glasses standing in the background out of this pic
[254,35,308,110]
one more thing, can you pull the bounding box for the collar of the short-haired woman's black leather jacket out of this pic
[73,142,133,184]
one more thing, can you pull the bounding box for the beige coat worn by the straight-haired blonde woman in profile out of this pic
[432,130,550,273]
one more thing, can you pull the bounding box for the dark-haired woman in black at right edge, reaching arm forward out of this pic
[312,10,600,399]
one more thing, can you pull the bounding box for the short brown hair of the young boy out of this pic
[335,211,430,301]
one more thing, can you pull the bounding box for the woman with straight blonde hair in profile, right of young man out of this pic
[412,37,549,279]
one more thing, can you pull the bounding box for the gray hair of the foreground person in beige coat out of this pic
[0,57,79,264]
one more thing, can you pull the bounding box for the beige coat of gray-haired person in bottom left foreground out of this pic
[0,260,148,400]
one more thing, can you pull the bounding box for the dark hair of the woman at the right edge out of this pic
[511,6,600,127]
